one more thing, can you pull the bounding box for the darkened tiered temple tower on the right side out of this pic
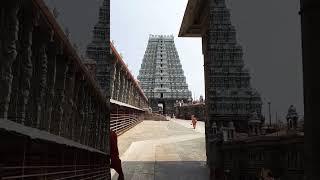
[206,0,264,132]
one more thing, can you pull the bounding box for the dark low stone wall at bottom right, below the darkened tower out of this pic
[222,136,304,180]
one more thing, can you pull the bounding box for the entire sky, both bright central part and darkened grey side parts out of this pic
[45,0,303,120]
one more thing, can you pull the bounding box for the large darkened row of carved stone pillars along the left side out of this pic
[0,0,109,153]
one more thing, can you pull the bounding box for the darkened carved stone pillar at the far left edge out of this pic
[0,0,19,118]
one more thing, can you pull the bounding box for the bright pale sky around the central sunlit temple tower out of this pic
[111,0,204,99]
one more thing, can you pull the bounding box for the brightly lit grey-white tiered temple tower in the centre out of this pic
[138,35,192,115]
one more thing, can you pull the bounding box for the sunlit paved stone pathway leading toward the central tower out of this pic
[112,119,209,180]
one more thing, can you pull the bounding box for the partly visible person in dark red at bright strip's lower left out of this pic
[109,130,124,180]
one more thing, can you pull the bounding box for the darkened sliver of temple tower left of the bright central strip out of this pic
[86,0,111,98]
